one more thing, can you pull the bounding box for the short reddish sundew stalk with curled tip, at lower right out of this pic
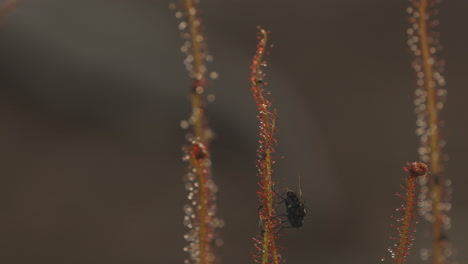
[388,162,428,264]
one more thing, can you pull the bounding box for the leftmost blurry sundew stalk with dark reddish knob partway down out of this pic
[176,0,221,264]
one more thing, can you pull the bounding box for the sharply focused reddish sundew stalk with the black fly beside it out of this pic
[250,28,282,264]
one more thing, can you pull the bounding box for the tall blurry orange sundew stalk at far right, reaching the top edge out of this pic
[408,0,450,264]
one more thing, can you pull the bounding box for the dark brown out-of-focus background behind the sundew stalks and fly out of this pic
[0,0,468,264]
